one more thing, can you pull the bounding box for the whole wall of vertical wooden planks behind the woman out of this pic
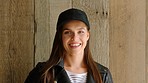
[0,0,148,83]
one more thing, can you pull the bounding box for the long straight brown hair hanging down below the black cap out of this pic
[40,22,102,83]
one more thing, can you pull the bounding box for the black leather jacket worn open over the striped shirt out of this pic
[25,61,113,83]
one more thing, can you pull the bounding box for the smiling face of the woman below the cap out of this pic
[62,20,89,55]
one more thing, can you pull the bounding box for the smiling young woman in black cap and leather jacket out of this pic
[25,8,113,83]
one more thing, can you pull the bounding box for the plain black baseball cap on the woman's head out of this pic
[56,8,90,30]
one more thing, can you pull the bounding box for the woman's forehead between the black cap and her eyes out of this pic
[63,20,87,30]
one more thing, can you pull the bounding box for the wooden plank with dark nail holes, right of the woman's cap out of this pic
[73,0,109,67]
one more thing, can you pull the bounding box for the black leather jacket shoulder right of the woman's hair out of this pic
[96,62,113,83]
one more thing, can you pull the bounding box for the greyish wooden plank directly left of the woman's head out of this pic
[35,0,71,63]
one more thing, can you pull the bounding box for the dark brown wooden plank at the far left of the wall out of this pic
[0,0,34,83]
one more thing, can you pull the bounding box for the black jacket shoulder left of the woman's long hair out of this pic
[25,62,46,83]
